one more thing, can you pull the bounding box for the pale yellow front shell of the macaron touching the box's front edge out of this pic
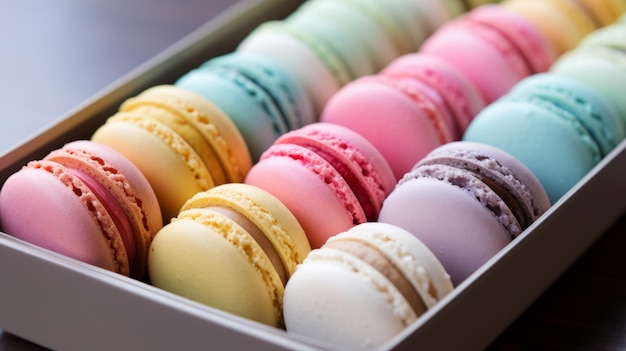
[148,219,282,326]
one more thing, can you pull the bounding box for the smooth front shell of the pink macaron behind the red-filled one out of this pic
[321,79,450,179]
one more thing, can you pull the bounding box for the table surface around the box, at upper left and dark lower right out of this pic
[0,0,626,350]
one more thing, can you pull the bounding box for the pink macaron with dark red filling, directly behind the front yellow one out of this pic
[245,123,396,248]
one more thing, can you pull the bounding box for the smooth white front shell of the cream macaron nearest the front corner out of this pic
[284,250,415,349]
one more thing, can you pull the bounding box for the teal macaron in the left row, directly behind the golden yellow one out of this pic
[175,52,317,162]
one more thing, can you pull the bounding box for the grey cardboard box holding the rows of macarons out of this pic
[0,0,626,350]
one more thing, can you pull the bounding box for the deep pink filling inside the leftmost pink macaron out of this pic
[71,169,136,264]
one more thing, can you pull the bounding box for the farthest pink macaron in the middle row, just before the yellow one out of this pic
[420,5,556,103]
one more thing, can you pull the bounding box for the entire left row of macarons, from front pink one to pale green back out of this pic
[0,0,498,320]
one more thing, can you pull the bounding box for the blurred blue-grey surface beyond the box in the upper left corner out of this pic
[0,0,237,151]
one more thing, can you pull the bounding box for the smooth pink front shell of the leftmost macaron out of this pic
[0,162,120,274]
